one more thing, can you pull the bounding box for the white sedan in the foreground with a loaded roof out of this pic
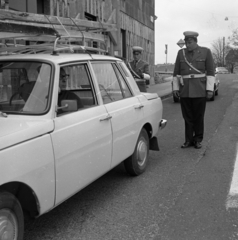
[0,48,167,240]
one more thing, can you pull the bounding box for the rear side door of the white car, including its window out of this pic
[92,62,143,167]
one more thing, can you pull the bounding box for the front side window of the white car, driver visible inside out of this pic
[57,64,97,115]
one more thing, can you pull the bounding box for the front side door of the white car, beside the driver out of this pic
[52,64,112,204]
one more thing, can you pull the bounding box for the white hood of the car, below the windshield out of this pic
[0,117,54,150]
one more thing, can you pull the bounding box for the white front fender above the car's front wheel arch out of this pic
[0,131,55,214]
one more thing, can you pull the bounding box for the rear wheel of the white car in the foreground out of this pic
[124,129,150,176]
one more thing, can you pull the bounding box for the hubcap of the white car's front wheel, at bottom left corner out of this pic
[0,209,17,240]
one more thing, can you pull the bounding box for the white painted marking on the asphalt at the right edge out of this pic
[226,144,238,210]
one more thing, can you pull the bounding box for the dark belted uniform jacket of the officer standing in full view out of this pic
[173,46,214,98]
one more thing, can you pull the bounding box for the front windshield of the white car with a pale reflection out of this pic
[0,61,51,114]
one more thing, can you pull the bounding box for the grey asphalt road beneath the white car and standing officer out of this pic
[25,75,238,240]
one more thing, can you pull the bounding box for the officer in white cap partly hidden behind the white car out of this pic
[128,46,150,92]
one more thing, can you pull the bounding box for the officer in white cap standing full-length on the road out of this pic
[173,31,215,149]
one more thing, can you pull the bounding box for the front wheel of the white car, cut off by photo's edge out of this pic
[0,192,24,240]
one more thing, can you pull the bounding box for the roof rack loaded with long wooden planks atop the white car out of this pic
[0,9,115,56]
